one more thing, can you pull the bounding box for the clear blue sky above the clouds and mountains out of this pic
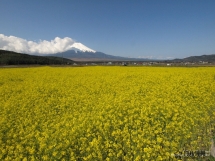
[0,0,215,58]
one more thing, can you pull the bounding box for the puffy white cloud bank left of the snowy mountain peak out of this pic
[0,34,75,54]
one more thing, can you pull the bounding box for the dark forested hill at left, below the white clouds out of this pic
[0,50,74,65]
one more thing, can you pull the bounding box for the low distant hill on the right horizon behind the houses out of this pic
[172,54,215,63]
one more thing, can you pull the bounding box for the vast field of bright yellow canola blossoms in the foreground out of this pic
[0,67,215,161]
